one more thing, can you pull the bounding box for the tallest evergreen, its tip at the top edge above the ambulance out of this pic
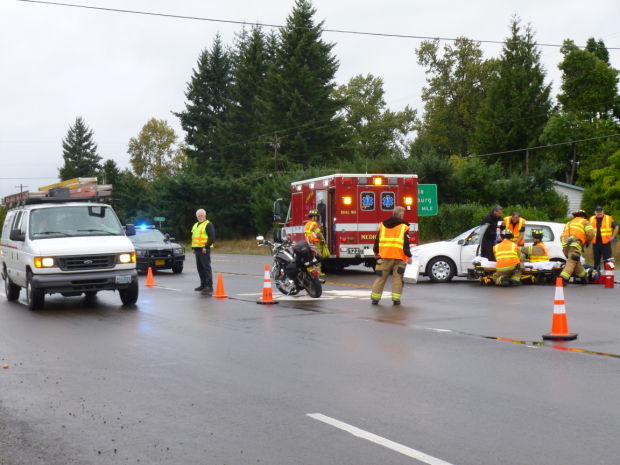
[268,0,343,166]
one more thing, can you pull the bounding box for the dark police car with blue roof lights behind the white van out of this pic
[125,225,185,273]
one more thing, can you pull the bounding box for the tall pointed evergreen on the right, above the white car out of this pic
[473,18,551,169]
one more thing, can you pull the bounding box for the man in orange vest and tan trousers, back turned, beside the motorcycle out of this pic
[370,207,411,305]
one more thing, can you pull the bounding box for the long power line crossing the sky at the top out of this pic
[18,0,620,50]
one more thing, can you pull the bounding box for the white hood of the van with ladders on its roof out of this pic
[32,236,134,255]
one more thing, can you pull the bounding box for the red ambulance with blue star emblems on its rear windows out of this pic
[283,174,418,270]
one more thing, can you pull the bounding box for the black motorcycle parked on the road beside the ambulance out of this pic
[256,236,323,298]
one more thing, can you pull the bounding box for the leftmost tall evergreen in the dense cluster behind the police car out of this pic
[175,34,232,173]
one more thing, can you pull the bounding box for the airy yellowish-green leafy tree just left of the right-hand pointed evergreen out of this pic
[416,37,497,157]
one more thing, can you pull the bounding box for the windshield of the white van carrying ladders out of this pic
[29,205,125,239]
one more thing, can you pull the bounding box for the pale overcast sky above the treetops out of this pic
[0,0,620,197]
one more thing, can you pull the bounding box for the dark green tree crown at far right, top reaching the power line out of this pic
[558,39,618,118]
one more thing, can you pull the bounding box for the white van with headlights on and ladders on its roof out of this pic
[0,199,138,310]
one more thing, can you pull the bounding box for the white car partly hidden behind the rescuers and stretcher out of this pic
[411,221,566,283]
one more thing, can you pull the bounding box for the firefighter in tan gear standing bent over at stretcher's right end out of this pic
[560,210,594,284]
